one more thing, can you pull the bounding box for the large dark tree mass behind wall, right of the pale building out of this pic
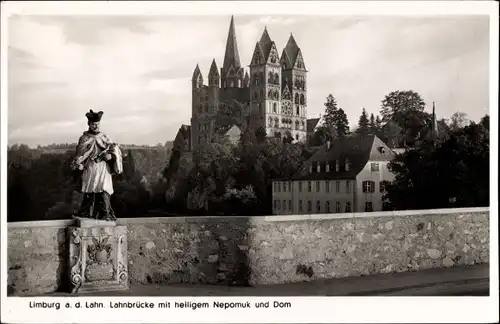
[385,124,489,209]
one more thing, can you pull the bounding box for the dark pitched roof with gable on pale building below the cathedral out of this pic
[278,135,395,180]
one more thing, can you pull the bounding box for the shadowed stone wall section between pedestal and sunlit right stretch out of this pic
[128,216,254,286]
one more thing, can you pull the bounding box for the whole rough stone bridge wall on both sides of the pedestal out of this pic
[8,208,489,295]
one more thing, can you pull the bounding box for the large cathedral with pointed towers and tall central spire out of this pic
[190,17,307,149]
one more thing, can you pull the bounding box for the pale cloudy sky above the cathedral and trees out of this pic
[8,15,489,146]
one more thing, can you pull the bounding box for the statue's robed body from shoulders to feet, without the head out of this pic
[73,132,123,220]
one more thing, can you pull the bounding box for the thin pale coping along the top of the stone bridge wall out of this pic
[7,207,490,229]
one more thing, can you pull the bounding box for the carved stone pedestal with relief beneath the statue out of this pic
[68,219,129,293]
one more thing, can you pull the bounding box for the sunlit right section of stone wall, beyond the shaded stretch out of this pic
[248,209,489,284]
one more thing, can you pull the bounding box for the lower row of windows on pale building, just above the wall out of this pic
[274,200,373,213]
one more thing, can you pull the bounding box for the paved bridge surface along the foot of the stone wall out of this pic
[58,264,490,296]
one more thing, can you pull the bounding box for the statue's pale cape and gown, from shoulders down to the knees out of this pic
[74,132,123,195]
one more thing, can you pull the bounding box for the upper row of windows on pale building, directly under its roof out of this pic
[273,180,387,193]
